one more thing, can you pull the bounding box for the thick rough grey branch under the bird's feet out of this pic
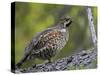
[15,48,97,73]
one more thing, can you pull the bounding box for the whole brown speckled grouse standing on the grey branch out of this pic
[15,17,72,69]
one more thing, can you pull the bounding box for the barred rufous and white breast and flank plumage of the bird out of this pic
[32,29,68,60]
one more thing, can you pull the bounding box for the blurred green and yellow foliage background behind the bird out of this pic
[13,2,97,68]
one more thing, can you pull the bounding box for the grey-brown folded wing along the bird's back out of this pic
[25,28,52,54]
